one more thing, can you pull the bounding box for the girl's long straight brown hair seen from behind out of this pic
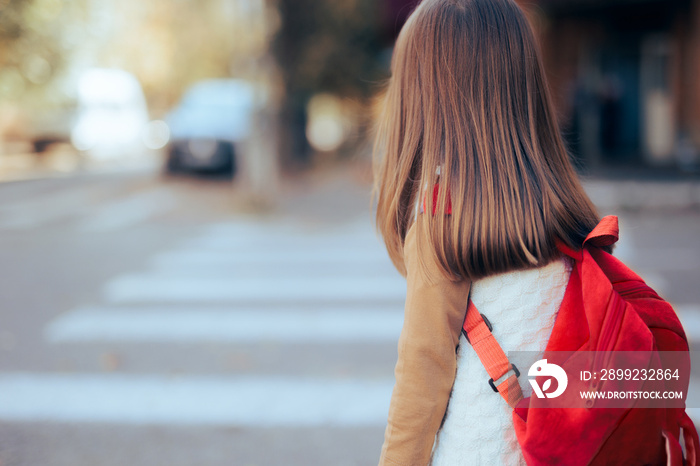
[374,0,599,280]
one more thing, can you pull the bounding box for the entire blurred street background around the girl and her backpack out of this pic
[0,0,700,466]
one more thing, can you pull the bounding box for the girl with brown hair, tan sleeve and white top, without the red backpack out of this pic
[375,0,599,465]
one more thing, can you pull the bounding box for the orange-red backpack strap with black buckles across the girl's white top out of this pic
[462,299,523,408]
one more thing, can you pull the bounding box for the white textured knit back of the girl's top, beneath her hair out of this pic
[431,258,572,466]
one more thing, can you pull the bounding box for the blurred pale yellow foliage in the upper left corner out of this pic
[0,0,271,114]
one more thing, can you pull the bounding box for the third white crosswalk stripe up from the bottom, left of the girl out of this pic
[104,274,406,303]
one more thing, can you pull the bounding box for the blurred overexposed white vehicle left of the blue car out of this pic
[71,68,149,159]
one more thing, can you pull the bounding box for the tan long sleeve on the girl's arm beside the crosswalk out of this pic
[379,215,471,466]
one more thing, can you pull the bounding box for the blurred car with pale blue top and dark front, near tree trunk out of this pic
[165,79,255,175]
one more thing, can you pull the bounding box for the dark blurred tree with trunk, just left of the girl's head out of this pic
[272,0,391,165]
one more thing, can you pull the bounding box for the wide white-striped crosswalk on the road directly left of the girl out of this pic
[0,219,405,428]
